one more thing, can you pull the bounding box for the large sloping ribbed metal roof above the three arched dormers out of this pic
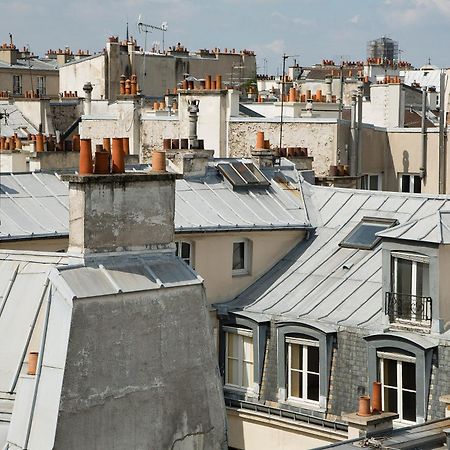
[225,183,450,329]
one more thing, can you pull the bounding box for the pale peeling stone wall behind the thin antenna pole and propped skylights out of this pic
[228,119,337,176]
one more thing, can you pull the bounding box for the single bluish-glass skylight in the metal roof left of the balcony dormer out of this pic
[339,217,397,250]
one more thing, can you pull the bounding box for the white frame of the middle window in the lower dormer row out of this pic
[286,336,321,406]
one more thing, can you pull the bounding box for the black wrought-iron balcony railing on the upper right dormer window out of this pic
[385,292,431,328]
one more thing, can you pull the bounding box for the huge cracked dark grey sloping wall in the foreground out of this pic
[54,285,227,450]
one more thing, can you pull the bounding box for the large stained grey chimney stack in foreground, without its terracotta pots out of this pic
[62,172,176,255]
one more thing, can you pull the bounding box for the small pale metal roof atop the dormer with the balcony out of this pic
[377,211,450,244]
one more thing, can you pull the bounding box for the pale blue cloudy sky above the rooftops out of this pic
[0,0,450,73]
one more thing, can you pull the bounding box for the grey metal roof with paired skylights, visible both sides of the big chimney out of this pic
[0,160,308,240]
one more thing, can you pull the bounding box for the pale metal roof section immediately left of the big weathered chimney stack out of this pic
[0,173,69,240]
